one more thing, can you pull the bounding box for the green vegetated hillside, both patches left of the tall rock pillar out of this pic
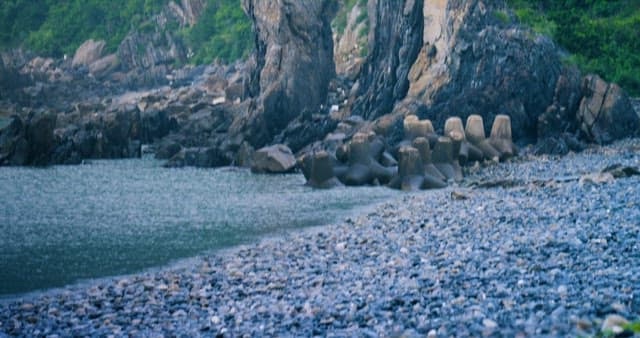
[0,0,252,63]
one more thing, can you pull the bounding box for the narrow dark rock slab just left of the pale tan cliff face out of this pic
[352,0,428,120]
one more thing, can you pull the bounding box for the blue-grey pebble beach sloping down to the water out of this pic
[0,140,640,337]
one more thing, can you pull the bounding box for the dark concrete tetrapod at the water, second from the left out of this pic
[338,133,395,186]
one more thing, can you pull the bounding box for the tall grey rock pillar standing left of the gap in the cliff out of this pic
[242,0,336,146]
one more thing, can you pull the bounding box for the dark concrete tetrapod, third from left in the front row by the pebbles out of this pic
[389,146,447,191]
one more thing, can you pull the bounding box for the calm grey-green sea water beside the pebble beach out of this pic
[0,159,396,295]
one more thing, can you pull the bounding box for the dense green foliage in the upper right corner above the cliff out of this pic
[509,0,640,96]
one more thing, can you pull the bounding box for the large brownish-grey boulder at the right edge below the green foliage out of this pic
[577,75,640,144]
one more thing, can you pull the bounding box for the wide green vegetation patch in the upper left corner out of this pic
[0,0,166,57]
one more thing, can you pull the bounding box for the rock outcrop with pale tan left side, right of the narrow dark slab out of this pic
[400,0,564,139]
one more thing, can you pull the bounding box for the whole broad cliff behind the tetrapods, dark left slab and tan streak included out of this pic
[352,0,635,142]
